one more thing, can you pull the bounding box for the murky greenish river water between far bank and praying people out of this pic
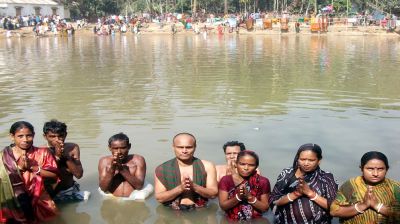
[0,35,400,224]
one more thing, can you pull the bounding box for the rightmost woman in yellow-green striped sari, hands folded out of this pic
[331,151,400,224]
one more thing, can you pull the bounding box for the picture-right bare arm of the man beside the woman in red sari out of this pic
[63,143,83,179]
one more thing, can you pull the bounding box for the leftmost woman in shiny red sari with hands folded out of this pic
[0,121,57,223]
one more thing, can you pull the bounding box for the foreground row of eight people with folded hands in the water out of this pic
[0,120,400,224]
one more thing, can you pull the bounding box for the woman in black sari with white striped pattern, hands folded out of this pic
[269,144,338,224]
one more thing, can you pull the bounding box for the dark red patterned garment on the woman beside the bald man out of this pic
[218,173,271,220]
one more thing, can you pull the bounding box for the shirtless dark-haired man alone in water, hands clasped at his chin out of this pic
[98,133,146,197]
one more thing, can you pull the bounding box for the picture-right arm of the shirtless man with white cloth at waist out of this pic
[119,155,146,190]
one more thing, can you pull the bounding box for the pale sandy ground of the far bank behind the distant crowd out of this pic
[0,23,400,39]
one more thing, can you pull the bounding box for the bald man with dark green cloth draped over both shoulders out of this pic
[154,133,218,210]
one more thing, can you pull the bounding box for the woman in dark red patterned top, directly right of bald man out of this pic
[218,150,270,220]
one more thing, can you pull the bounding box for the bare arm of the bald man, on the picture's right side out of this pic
[193,160,218,198]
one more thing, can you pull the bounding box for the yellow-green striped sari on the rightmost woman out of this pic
[331,176,400,224]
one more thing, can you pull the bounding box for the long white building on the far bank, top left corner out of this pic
[0,0,65,18]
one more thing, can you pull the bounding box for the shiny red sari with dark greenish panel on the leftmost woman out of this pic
[0,147,58,223]
